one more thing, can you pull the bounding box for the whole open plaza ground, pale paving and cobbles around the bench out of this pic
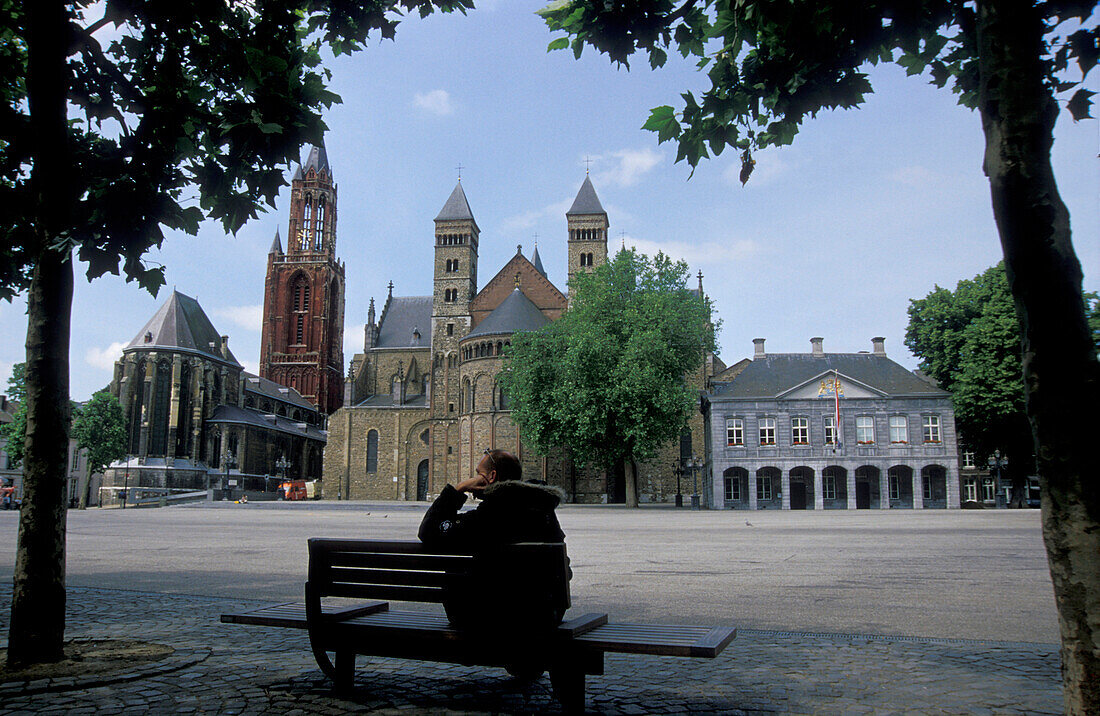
[0,503,1060,714]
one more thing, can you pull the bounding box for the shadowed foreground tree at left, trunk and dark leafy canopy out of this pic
[0,0,472,665]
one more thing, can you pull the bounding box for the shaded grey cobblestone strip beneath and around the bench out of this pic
[0,587,1062,715]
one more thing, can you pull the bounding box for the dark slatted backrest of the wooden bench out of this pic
[308,538,570,613]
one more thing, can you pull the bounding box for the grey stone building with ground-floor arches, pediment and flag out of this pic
[704,338,959,509]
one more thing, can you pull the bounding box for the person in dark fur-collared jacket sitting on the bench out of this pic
[419,450,565,631]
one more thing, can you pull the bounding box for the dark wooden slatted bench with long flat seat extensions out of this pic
[221,538,737,711]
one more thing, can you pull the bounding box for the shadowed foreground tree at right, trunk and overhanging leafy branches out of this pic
[542,0,1100,714]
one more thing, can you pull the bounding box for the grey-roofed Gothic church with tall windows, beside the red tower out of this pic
[102,291,325,502]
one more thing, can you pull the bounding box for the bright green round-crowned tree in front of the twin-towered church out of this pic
[502,250,714,507]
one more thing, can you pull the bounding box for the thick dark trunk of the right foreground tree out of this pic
[978,0,1100,714]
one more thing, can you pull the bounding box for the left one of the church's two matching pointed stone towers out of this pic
[431,179,481,418]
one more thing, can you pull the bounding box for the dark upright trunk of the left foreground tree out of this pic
[8,1,73,665]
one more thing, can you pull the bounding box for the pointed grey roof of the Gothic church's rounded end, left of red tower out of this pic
[122,289,241,367]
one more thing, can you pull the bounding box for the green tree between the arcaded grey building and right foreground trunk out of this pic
[905,263,1034,507]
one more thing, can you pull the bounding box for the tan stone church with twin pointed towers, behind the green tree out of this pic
[325,176,725,503]
